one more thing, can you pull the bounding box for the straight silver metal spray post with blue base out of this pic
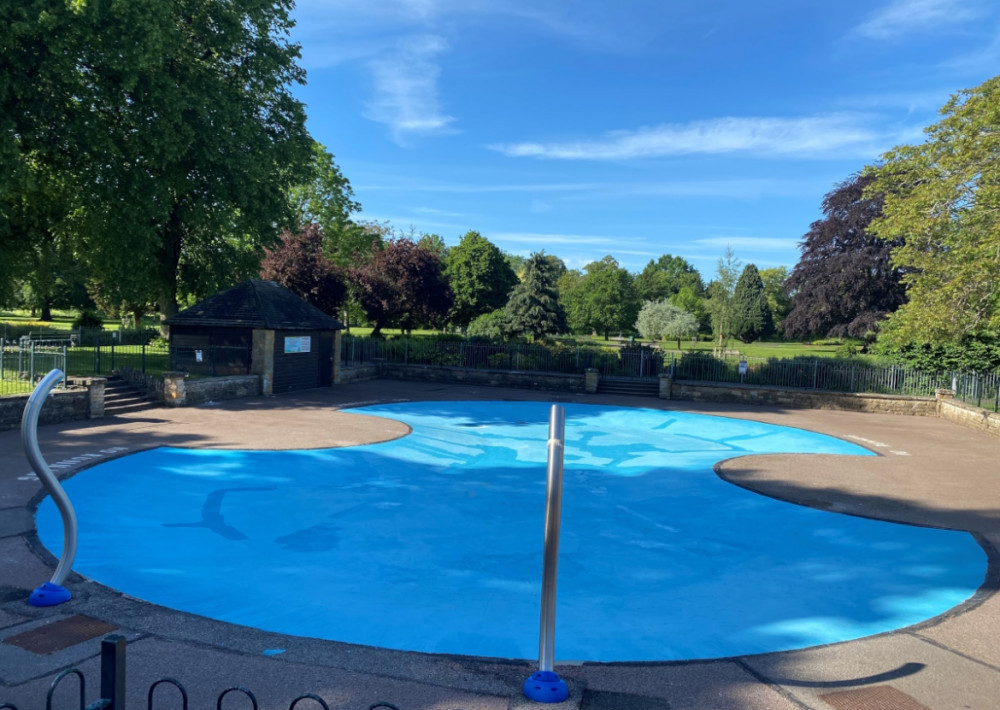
[524,404,569,703]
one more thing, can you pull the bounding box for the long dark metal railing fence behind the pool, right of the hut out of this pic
[341,336,1000,411]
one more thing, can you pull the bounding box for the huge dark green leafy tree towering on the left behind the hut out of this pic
[0,0,312,334]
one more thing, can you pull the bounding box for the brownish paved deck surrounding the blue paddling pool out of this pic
[0,380,1000,710]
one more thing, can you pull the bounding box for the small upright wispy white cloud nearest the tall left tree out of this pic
[365,35,455,145]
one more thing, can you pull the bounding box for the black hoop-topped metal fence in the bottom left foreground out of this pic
[0,635,446,710]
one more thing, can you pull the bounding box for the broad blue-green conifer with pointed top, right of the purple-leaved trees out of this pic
[504,252,567,340]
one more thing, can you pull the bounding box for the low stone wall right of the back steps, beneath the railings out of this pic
[661,380,937,417]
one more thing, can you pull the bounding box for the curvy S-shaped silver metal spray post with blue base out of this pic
[21,370,76,606]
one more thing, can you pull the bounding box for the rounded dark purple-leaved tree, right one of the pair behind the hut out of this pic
[349,237,452,338]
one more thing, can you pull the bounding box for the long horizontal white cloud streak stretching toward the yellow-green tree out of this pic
[488,113,891,160]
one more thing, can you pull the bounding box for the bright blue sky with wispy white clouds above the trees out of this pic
[292,0,1000,278]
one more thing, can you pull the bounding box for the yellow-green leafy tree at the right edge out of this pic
[868,76,1000,343]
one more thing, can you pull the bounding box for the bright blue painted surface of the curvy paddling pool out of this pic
[38,402,986,661]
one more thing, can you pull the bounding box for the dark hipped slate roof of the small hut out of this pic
[166,279,344,330]
